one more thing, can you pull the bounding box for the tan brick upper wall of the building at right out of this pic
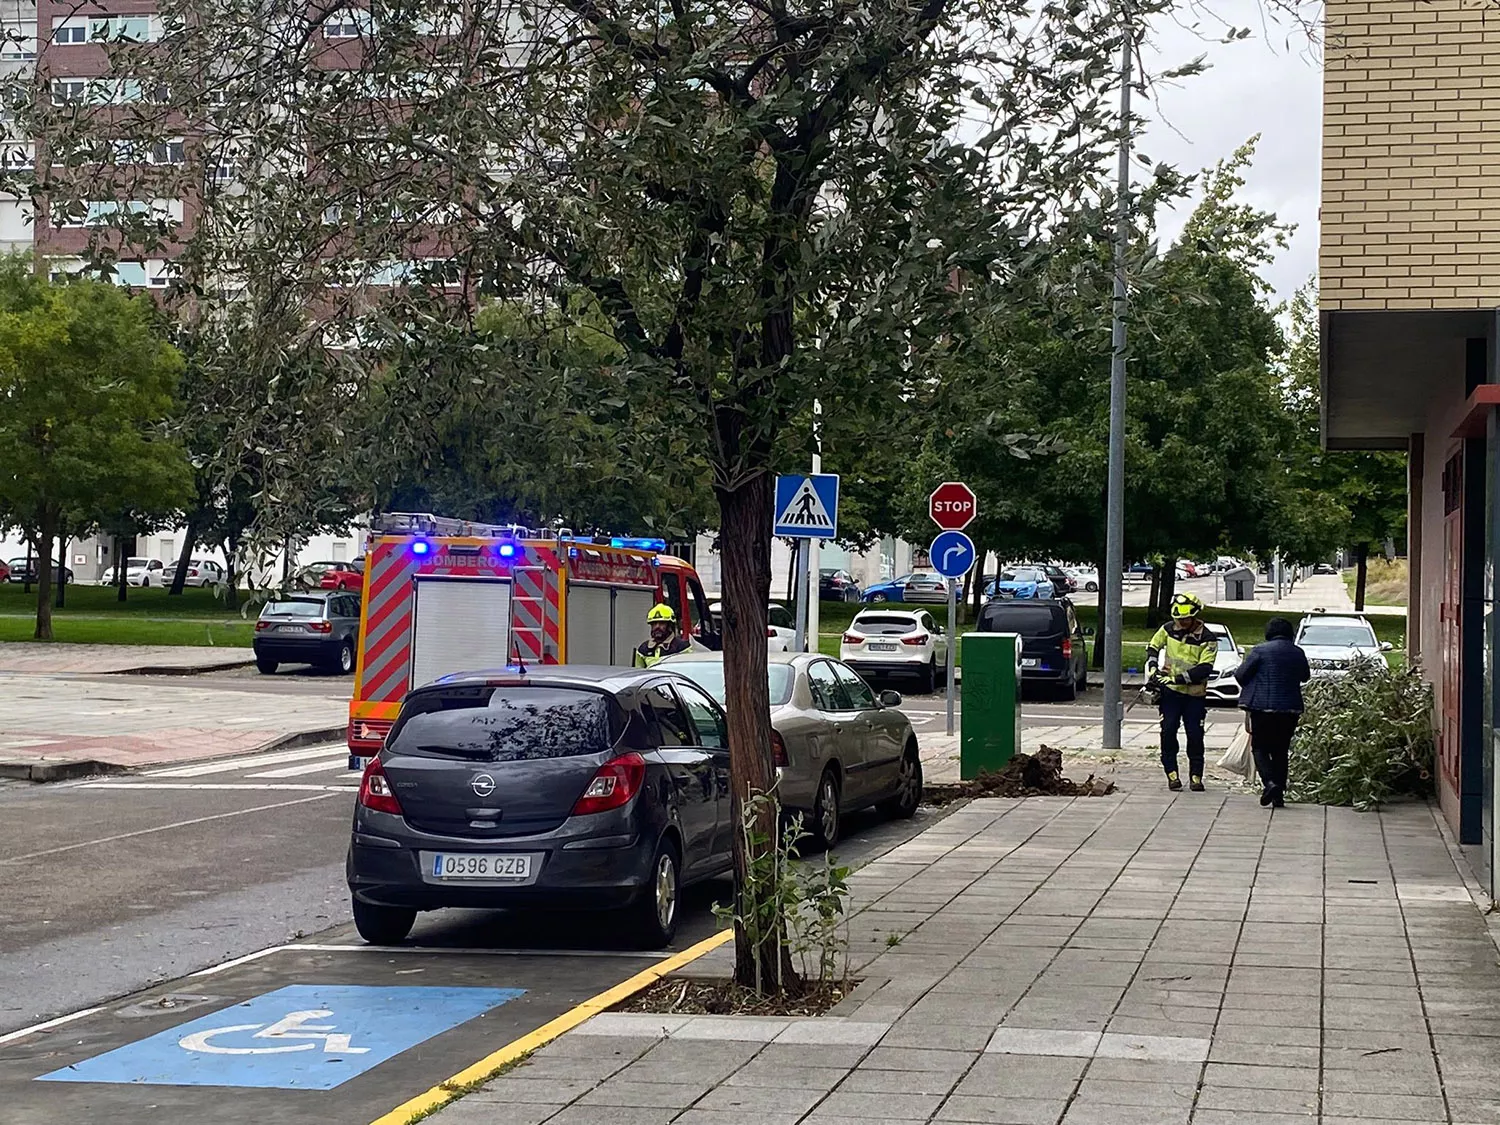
[1319,0,1500,309]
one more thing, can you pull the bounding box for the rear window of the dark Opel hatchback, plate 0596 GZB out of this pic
[392,687,626,762]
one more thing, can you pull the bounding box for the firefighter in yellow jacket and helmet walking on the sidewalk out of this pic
[1146,594,1218,794]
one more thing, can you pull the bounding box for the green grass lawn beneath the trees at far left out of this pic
[0,582,255,648]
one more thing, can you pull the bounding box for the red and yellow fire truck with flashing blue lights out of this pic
[348,512,719,770]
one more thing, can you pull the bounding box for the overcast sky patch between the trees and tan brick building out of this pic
[1143,11,1323,299]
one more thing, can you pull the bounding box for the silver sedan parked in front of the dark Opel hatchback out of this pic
[662,653,923,848]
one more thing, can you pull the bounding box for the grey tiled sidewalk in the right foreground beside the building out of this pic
[434,788,1500,1125]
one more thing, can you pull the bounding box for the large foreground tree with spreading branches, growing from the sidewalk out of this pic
[32,0,1182,987]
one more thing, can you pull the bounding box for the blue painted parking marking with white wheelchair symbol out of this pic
[38,984,525,1091]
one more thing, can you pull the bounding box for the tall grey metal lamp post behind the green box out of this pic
[1104,11,1136,750]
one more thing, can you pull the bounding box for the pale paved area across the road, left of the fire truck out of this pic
[0,674,348,780]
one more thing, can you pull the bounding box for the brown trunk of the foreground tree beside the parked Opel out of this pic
[717,473,800,992]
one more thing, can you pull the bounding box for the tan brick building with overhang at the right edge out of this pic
[1319,0,1500,894]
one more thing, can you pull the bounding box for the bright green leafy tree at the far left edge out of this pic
[0,258,188,641]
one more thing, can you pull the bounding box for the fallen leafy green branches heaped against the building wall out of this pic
[1287,659,1434,810]
